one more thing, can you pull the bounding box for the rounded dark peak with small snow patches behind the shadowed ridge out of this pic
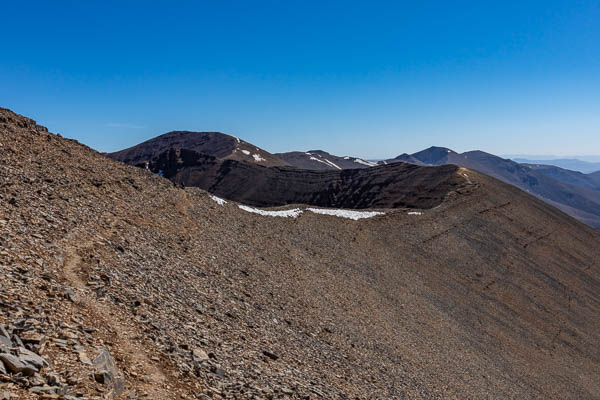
[107,131,288,167]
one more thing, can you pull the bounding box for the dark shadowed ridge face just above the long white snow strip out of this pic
[124,149,472,208]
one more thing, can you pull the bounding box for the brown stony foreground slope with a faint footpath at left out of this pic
[0,110,600,399]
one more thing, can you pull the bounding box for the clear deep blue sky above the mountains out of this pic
[0,0,600,158]
